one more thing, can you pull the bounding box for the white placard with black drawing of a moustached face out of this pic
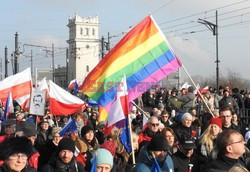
[29,89,46,116]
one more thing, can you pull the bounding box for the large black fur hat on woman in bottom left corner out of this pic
[0,137,32,160]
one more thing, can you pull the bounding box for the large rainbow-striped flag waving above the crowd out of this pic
[81,16,181,109]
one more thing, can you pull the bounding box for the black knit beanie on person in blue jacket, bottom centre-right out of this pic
[148,134,170,151]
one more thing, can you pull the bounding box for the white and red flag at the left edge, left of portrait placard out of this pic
[0,68,32,108]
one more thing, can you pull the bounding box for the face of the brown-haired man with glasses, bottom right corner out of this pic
[227,133,246,159]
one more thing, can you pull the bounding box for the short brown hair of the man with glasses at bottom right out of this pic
[216,129,241,155]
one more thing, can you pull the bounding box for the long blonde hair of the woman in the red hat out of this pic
[200,124,222,154]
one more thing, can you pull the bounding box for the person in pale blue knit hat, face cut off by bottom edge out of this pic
[91,148,113,172]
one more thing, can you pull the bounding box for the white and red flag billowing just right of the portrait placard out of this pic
[49,80,85,116]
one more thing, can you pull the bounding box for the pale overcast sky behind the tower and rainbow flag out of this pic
[0,0,250,79]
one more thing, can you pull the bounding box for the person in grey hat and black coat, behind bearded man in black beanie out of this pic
[39,127,62,169]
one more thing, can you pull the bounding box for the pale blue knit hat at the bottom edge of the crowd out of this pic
[92,148,113,168]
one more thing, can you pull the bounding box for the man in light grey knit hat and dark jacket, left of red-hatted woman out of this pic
[171,112,193,140]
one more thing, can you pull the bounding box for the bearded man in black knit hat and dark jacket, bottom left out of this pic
[41,138,85,172]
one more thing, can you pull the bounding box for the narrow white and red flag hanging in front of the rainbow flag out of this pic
[108,75,129,126]
